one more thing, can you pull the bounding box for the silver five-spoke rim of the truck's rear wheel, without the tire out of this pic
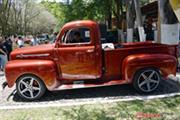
[138,70,160,92]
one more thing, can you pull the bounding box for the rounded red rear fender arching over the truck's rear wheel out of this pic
[122,54,177,83]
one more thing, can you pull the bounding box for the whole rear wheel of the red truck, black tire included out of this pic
[133,68,162,93]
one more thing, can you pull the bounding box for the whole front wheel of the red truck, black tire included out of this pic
[16,75,46,101]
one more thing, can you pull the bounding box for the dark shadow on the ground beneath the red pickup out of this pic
[13,80,180,102]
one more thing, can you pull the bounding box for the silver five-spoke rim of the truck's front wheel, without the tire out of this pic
[18,77,41,99]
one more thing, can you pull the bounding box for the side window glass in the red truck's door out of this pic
[61,28,91,44]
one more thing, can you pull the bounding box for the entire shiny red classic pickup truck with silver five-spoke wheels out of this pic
[5,20,177,100]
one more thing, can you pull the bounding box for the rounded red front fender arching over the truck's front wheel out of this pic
[5,60,57,90]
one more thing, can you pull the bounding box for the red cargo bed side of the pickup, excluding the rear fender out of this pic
[103,42,176,80]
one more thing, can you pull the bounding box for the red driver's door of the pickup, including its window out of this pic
[58,27,102,80]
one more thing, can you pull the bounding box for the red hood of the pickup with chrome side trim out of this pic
[10,44,55,60]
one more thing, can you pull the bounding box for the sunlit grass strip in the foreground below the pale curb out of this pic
[0,96,180,120]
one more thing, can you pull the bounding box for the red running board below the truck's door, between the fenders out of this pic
[55,80,128,90]
